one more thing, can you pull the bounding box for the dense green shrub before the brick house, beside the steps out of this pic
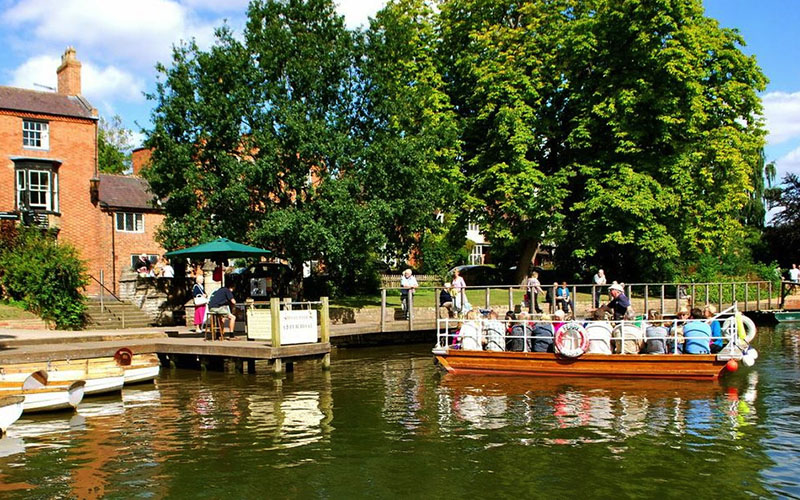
[0,229,88,329]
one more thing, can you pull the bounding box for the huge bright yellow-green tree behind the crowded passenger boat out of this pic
[442,0,766,279]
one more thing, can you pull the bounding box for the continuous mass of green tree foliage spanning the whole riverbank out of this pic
[146,0,774,290]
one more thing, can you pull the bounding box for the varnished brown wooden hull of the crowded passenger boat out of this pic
[434,349,727,380]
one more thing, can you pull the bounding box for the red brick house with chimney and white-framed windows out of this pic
[0,47,163,294]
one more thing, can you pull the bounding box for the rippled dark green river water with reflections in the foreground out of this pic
[0,326,800,498]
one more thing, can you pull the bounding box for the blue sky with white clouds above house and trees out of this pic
[0,0,800,184]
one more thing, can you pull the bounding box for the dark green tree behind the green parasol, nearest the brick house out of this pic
[145,0,383,290]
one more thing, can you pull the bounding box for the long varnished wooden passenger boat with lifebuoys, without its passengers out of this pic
[433,311,758,380]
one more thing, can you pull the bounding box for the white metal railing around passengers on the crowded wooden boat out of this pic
[436,305,738,354]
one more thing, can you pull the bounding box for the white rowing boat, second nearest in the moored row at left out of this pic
[0,370,86,413]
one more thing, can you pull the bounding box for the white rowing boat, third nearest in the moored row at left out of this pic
[0,359,125,396]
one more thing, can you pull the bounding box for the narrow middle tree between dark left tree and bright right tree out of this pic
[358,0,463,266]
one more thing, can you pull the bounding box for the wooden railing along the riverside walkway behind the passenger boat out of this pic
[380,281,776,332]
